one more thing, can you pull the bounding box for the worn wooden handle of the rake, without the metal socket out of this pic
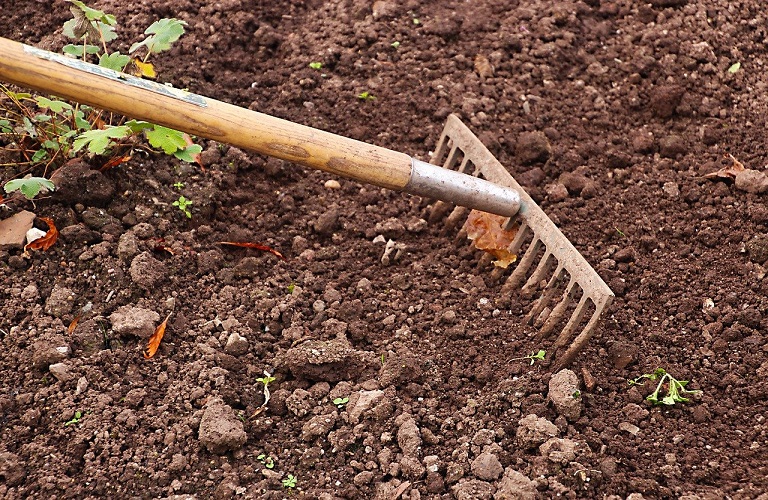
[0,38,411,190]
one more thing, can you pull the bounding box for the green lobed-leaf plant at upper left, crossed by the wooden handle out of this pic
[0,0,202,197]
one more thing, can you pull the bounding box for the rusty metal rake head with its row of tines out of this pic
[430,115,614,371]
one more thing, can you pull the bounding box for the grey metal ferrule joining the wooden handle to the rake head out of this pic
[403,158,520,217]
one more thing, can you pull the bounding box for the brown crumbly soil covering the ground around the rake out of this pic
[0,0,768,499]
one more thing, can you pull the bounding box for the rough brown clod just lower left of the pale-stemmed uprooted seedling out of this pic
[198,398,248,455]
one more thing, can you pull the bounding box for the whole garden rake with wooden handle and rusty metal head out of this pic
[0,38,613,369]
